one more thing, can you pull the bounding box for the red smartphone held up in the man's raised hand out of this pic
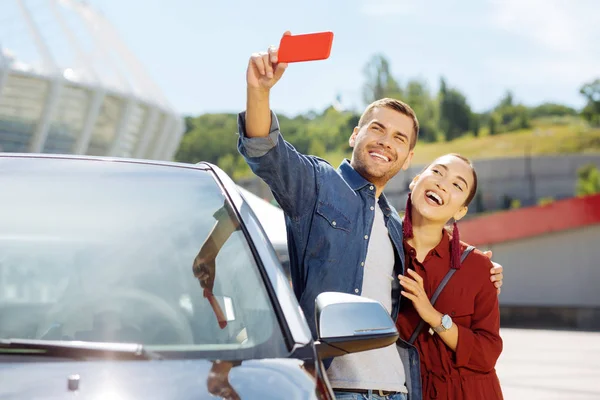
[277,32,333,63]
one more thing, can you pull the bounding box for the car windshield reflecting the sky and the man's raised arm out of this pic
[0,158,286,359]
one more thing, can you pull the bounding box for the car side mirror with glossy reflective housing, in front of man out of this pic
[315,292,399,358]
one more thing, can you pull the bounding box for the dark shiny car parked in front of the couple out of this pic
[0,154,398,400]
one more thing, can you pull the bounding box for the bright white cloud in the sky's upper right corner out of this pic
[484,0,600,90]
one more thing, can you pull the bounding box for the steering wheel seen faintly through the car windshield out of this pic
[36,288,194,345]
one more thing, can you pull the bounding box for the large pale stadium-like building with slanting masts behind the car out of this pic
[0,0,184,160]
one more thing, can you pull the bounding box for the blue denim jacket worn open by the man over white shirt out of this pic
[238,113,421,400]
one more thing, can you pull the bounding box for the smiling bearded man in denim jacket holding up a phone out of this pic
[232,32,502,400]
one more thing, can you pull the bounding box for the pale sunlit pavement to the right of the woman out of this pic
[496,329,600,400]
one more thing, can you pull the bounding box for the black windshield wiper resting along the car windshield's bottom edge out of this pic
[0,339,162,360]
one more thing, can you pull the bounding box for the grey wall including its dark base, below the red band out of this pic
[478,225,600,331]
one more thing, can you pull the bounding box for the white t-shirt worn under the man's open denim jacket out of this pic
[327,202,408,393]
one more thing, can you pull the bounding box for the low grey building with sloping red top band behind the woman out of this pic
[459,195,600,330]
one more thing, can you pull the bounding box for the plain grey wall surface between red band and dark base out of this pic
[478,225,600,308]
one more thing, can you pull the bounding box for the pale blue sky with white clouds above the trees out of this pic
[69,0,600,115]
